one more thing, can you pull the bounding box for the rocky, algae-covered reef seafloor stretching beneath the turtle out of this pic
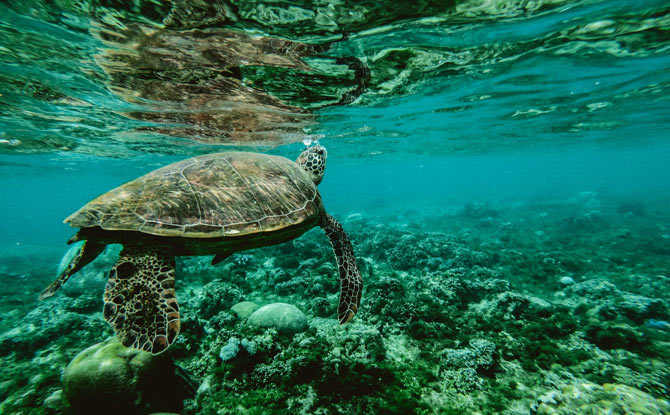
[0,192,670,415]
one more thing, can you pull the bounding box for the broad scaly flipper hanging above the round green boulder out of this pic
[103,245,180,354]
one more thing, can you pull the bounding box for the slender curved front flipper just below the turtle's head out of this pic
[321,213,363,324]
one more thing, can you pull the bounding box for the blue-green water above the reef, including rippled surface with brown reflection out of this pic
[0,0,670,413]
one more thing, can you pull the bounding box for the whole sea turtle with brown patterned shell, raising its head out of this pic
[40,145,363,354]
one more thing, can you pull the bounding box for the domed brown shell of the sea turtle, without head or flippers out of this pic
[65,152,323,238]
